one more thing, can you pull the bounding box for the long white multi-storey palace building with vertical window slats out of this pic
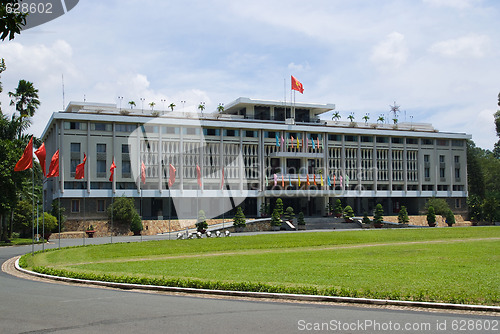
[42,97,471,219]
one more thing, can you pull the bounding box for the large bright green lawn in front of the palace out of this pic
[22,227,500,305]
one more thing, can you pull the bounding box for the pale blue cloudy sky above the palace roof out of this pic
[0,0,500,149]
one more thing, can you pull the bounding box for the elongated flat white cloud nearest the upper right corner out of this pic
[429,34,490,58]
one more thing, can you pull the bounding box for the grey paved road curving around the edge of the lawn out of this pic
[0,236,500,334]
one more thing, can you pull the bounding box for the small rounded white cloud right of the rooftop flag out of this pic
[370,32,408,69]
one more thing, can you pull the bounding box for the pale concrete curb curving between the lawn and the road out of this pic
[15,257,500,313]
